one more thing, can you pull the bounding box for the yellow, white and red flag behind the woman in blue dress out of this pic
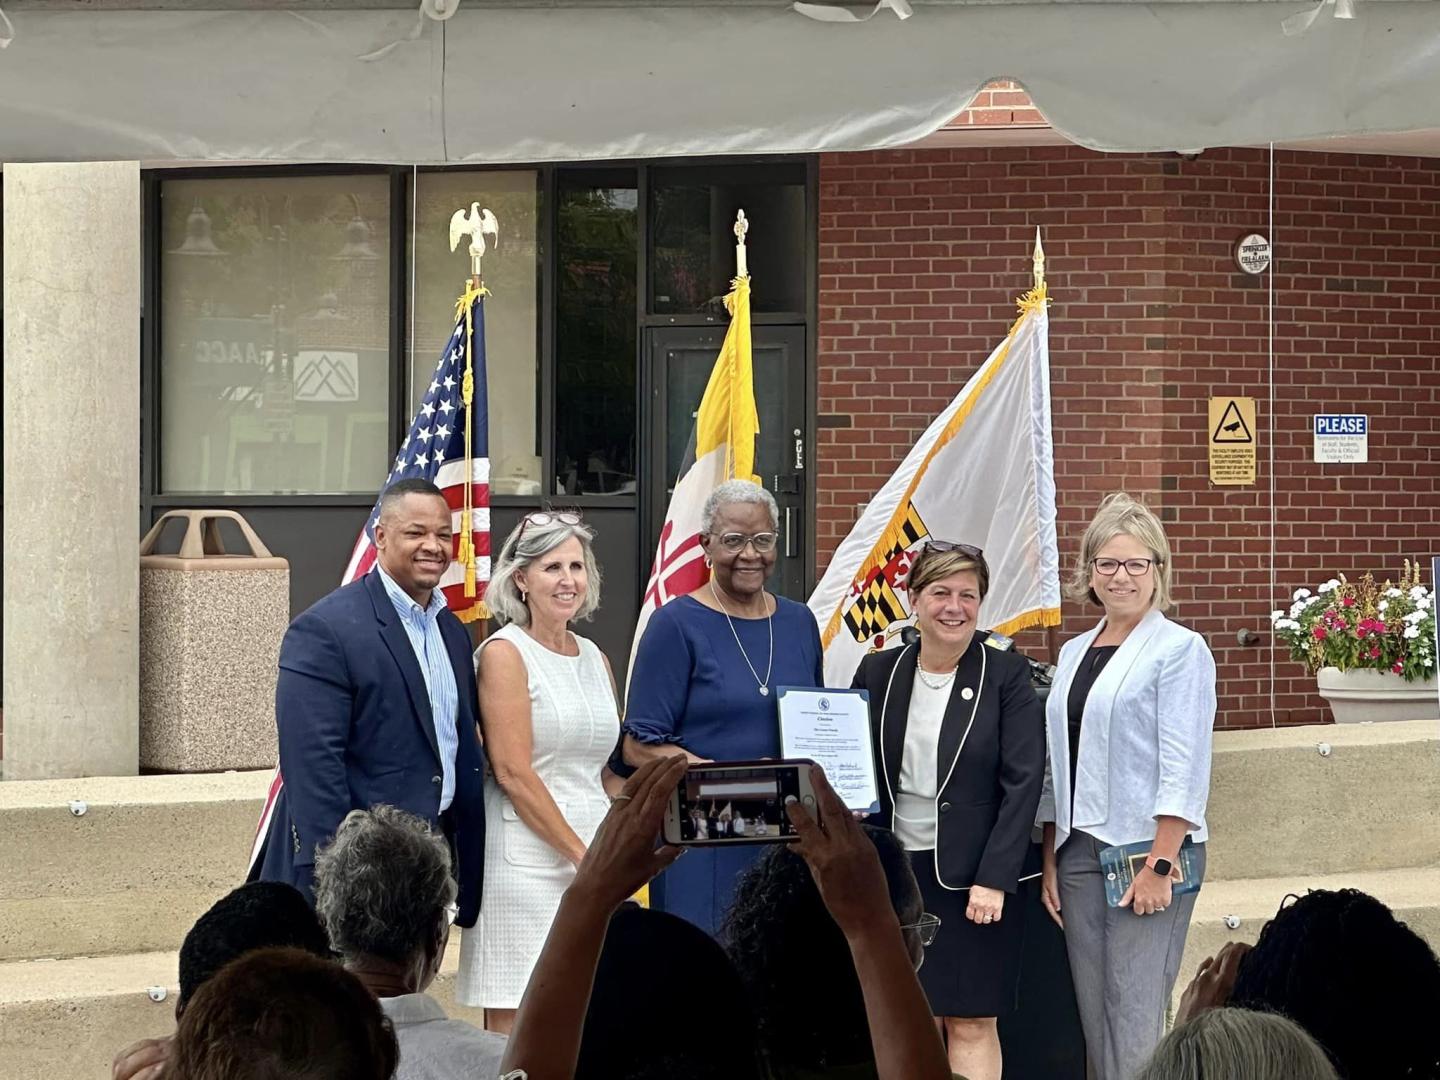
[626,276,760,685]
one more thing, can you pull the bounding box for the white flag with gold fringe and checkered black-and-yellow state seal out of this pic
[809,244,1060,687]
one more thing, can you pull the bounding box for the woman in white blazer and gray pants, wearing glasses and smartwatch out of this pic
[1038,494,1215,1080]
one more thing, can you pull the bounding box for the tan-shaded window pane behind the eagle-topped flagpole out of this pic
[408,170,541,495]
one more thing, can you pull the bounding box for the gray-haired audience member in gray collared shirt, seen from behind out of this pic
[315,805,505,1080]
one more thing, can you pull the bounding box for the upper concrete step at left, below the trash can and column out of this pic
[0,772,271,962]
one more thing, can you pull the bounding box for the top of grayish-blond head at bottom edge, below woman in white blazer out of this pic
[1135,1008,1336,1080]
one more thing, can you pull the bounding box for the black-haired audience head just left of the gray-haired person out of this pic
[176,881,330,1020]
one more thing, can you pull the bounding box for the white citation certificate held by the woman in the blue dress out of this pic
[778,687,880,814]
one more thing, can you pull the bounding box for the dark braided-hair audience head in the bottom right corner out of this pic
[1230,888,1440,1080]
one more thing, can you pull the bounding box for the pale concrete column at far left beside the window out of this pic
[3,161,141,779]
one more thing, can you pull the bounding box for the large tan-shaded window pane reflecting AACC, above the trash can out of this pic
[160,176,390,494]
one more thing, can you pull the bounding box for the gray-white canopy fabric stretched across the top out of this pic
[0,0,1440,164]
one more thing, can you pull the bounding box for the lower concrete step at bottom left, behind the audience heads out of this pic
[0,935,484,1080]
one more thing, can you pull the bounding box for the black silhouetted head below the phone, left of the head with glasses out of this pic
[575,904,759,1080]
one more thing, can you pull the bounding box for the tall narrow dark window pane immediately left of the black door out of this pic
[554,170,638,495]
